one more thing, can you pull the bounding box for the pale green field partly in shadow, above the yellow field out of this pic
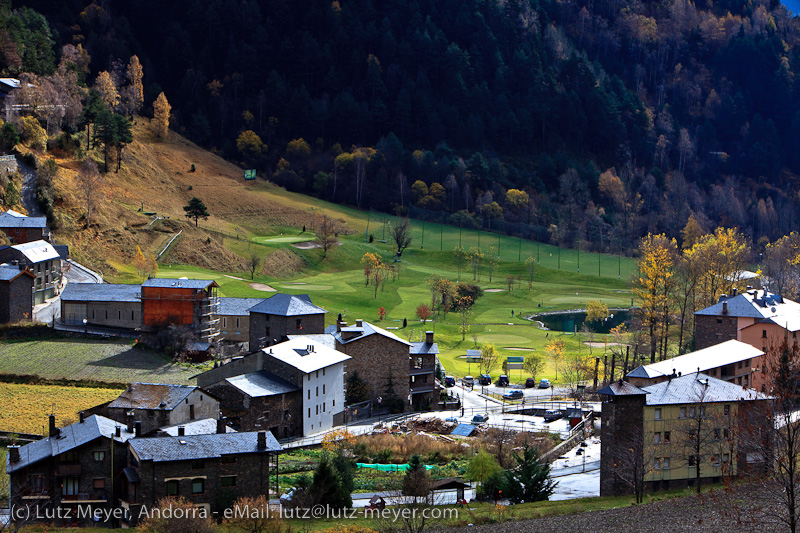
[0,338,206,384]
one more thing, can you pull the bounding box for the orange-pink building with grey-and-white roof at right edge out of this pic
[694,289,800,351]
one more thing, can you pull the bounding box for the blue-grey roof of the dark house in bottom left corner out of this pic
[6,415,133,473]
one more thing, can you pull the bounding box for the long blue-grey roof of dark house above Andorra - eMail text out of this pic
[129,431,283,463]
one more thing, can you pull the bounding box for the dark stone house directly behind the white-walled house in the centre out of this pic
[326,320,412,411]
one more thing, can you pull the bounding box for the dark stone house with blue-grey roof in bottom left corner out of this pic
[6,413,134,527]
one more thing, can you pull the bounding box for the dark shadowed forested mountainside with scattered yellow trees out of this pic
[0,0,800,251]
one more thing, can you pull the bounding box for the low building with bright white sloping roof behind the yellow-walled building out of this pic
[626,340,766,392]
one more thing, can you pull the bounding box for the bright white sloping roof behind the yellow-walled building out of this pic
[628,339,764,379]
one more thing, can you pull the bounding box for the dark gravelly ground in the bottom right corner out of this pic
[444,486,788,533]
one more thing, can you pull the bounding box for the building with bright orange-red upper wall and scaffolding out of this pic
[141,278,219,342]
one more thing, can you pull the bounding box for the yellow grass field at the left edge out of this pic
[0,383,122,434]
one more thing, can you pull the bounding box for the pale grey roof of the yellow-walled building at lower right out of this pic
[640,373,771,405]
